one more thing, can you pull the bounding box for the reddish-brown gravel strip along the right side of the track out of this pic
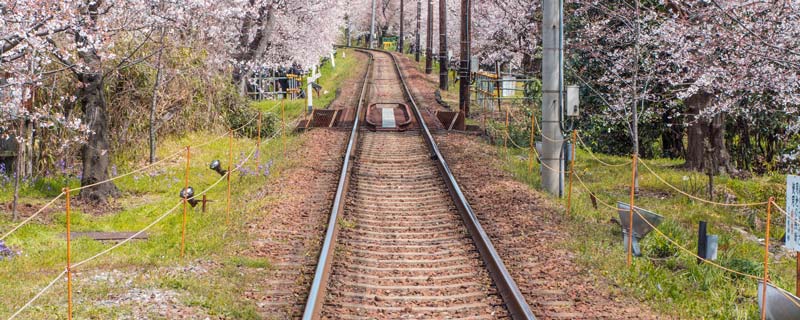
[392,50,665,319]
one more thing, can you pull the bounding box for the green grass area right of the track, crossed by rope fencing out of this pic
[500,139,796,319]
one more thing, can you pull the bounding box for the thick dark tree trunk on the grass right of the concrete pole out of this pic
[684,92,733,172]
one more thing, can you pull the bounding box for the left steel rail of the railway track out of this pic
[303,50,373,320]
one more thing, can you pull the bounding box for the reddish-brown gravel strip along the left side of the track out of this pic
[240,129,347,319]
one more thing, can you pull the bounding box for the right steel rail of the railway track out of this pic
[386,48,536,319]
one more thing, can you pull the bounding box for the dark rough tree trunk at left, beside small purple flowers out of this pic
[78,72,118,202]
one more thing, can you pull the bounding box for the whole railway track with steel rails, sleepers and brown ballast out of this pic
[303,51,534,319]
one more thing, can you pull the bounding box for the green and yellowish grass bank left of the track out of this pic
[0,50,358,319]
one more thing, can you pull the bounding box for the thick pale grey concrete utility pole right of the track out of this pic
[541,0,563,196]
